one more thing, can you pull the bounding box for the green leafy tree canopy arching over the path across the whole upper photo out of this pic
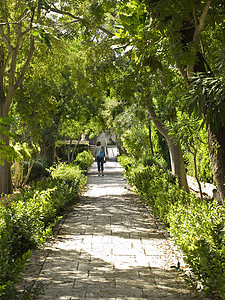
[0,0,225,196]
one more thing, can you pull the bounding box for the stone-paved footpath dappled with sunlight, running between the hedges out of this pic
[18,162,203,300]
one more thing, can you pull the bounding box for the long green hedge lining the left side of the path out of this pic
[0,164,86,299]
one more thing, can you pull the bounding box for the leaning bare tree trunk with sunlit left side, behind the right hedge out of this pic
[147,100,189,192]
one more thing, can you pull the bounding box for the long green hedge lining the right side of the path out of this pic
[118,157,225,299]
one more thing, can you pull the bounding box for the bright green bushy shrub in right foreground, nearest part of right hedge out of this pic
[169,197,225,299]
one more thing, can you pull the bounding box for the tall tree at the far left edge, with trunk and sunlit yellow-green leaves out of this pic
[0,0,104,193]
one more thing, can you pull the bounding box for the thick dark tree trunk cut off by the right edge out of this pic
[208,125,225,203]
